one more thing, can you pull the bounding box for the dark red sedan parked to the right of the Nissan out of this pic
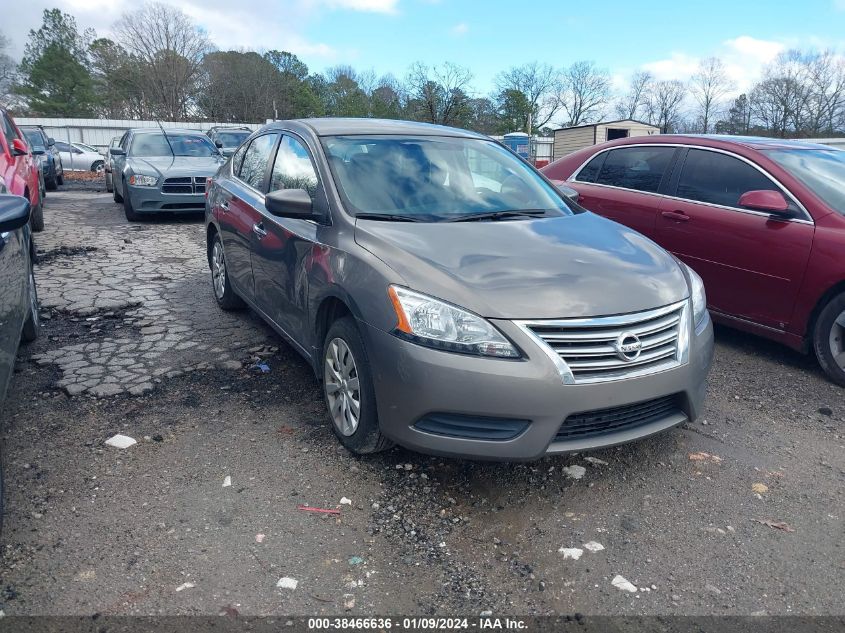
[542,135,845,385]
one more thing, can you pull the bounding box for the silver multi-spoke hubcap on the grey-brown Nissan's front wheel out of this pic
[323,338,361,436]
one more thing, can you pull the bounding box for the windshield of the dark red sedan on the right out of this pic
[765,149,845,215]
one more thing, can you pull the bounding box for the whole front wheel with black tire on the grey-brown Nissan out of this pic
[321,316,393,455]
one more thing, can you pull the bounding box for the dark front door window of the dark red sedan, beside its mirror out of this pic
[677,149,780,207]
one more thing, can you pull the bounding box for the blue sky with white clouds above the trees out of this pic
[0,0,845,95]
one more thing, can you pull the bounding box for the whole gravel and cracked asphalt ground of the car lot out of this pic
[0,186,845,615]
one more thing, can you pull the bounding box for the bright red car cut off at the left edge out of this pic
[0,107,44,231]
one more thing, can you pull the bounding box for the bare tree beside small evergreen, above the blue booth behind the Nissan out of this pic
[496,62,561,134]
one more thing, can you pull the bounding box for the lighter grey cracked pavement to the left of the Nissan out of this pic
[29,193,269,396]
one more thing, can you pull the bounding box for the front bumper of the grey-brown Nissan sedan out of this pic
[361,317,713,460]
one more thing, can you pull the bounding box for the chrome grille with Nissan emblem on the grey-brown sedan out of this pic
[517,301,689,384]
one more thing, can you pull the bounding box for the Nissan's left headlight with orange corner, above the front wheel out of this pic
[388,286,520,358]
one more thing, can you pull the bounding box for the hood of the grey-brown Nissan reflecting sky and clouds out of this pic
[355,213,689,319]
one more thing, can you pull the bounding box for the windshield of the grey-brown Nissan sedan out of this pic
[323,136,572,221]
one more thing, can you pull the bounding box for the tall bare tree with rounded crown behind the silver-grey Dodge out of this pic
[115,3,211,120]
